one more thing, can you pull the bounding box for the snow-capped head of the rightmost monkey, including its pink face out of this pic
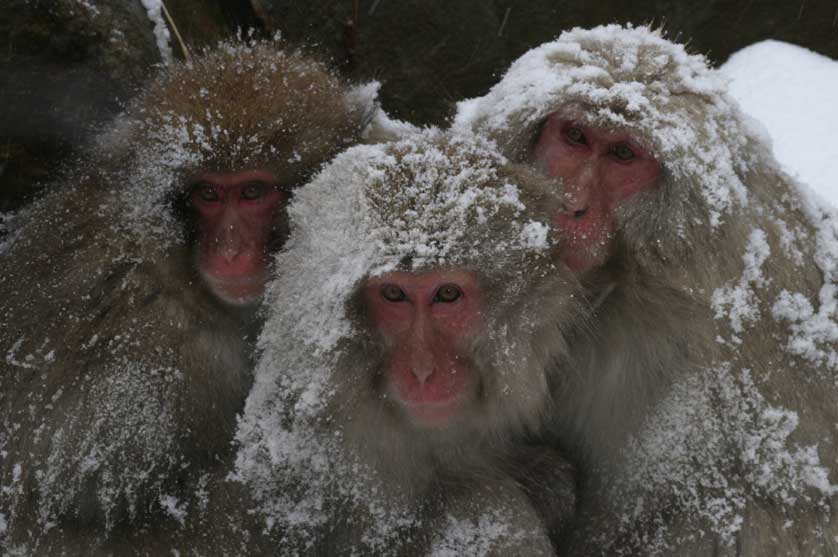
[455,25,764,280]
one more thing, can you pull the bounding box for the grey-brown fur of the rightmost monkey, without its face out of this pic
[466,26,838,556]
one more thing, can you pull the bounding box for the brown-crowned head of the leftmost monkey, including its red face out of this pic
[101,42,377,306]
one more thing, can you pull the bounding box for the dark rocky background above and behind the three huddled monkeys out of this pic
[0,0,838,213]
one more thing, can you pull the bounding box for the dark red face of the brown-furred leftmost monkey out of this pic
[189,170,288,305]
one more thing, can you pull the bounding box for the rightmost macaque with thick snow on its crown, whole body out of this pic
[455,25,838,555]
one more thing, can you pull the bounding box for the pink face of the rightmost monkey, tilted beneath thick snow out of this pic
[532,113,660,272]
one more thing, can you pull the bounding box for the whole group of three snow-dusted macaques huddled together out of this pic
[0,25,838,556]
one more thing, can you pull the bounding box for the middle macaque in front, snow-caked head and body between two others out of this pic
[236,130,583,555]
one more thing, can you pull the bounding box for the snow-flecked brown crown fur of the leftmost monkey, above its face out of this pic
[100,40,378,247]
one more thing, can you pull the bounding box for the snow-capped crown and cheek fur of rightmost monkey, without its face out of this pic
[455,21,776,264]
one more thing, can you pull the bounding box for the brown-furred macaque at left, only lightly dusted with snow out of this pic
[0,42,376,555]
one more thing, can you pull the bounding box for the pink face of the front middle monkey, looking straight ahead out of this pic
[364,270,481,427]
